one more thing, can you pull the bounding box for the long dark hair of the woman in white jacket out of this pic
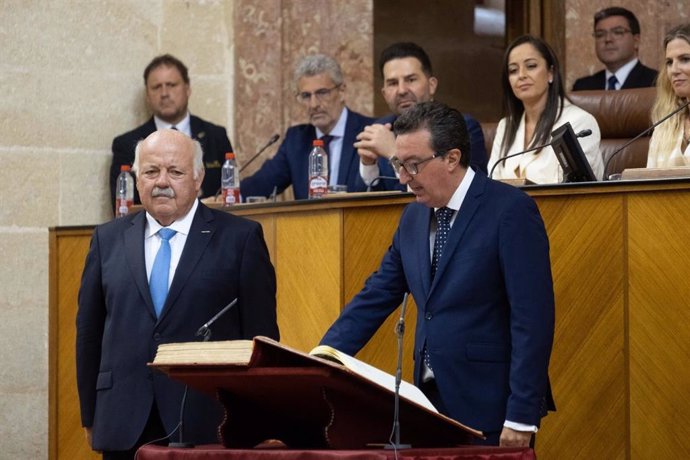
[501,35,567,156]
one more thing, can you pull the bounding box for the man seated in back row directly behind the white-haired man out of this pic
[110,54,232,210]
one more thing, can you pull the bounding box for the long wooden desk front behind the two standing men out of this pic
[50,180,690,459]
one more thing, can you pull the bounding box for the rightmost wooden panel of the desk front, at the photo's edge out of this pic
[628,192,690,458]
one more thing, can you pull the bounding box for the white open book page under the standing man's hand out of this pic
[309,345,438,413]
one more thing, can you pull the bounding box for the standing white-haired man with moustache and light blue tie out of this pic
[76,129,279,459]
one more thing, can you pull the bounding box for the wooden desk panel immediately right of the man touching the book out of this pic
[537,195,627,459]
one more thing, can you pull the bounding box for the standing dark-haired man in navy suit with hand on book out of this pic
[321,102,554,446]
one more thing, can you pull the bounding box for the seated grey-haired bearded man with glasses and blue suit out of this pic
[240,54,372,200]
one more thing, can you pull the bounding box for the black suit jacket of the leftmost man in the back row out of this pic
[110,115,232,206]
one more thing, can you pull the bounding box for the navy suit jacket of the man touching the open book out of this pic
[322,174,554,432]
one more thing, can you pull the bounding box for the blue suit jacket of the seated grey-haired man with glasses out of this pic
[240,109,373,200]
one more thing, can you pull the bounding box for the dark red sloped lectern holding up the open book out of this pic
[152,337,481,449]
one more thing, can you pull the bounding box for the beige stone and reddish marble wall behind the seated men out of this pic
[0,0,372,459]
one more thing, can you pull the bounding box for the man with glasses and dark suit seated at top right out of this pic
[573,6,657,91]
